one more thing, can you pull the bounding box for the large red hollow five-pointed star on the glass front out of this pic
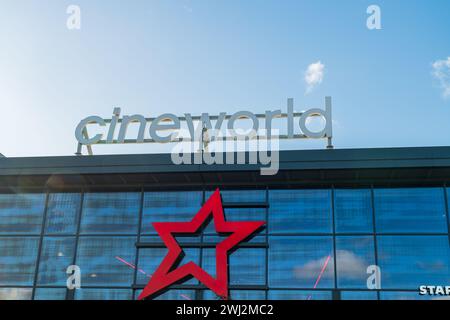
[138,189,265,300]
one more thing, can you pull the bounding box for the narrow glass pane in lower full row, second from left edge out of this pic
[38,237,75,286]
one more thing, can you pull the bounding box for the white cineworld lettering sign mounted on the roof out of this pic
[75,97,333,154]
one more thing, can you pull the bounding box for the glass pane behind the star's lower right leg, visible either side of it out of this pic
[202,248,266,285]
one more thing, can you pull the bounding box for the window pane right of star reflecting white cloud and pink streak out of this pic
[269,236,334,288]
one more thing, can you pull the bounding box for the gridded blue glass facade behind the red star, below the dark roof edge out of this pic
[0,187,450,300]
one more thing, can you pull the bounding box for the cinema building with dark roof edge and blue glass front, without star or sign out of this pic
[0,147,450,300]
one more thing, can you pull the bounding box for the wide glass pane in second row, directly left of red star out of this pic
[76,236,136,287]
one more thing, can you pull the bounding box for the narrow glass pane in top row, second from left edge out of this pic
[45,193,81,234]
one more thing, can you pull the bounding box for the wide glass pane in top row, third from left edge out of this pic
[81,192,141,234]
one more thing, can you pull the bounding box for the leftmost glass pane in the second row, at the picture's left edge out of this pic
[0,237,39,286]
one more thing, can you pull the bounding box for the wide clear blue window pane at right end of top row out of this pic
[374,188,448,232]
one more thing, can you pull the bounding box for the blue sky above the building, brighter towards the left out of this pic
[0,0,450,156]
